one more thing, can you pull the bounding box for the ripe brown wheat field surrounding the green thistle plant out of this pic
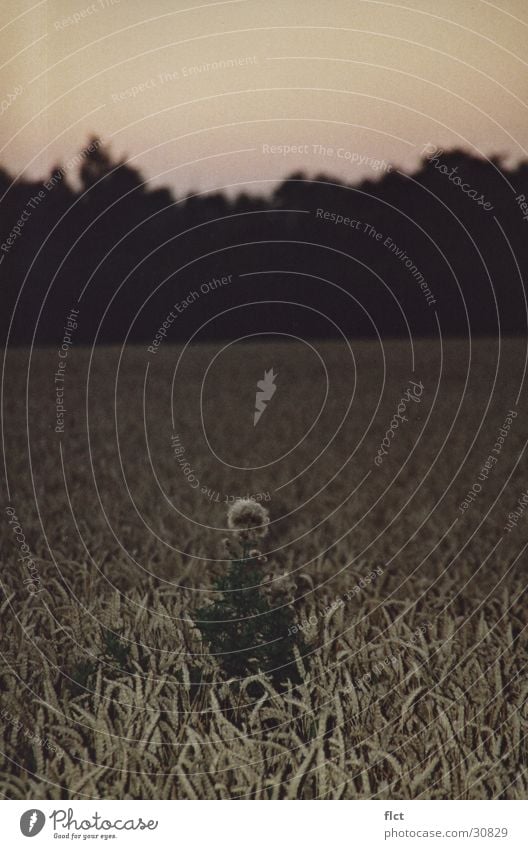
[0,339,528,799]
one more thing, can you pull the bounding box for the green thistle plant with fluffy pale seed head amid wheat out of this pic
[195,498,304,685]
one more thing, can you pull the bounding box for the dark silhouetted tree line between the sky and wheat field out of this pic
[0,142,528,345]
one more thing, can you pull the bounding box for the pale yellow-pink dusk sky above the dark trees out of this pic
[0,0,528,195]
